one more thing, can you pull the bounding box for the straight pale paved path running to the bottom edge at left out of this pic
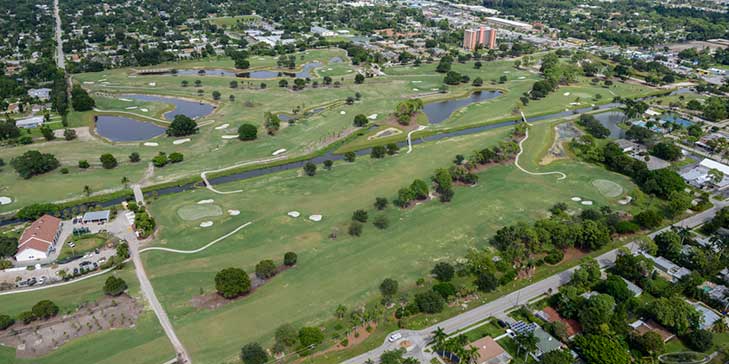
[112,220,192,364]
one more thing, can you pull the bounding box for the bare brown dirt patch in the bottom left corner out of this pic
[0,295,144,358]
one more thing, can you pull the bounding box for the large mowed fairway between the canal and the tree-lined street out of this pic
[143,123,635,363]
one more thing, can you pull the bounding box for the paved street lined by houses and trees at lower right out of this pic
[344,201,729,364]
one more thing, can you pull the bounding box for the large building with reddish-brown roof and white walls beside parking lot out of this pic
[15,215,62,262]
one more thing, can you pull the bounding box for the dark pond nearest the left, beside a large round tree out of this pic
[96,115,166,142]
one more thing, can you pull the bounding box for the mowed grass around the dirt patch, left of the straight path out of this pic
[0,265,175,364]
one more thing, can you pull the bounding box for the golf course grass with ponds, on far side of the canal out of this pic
[0,52,653,213]
